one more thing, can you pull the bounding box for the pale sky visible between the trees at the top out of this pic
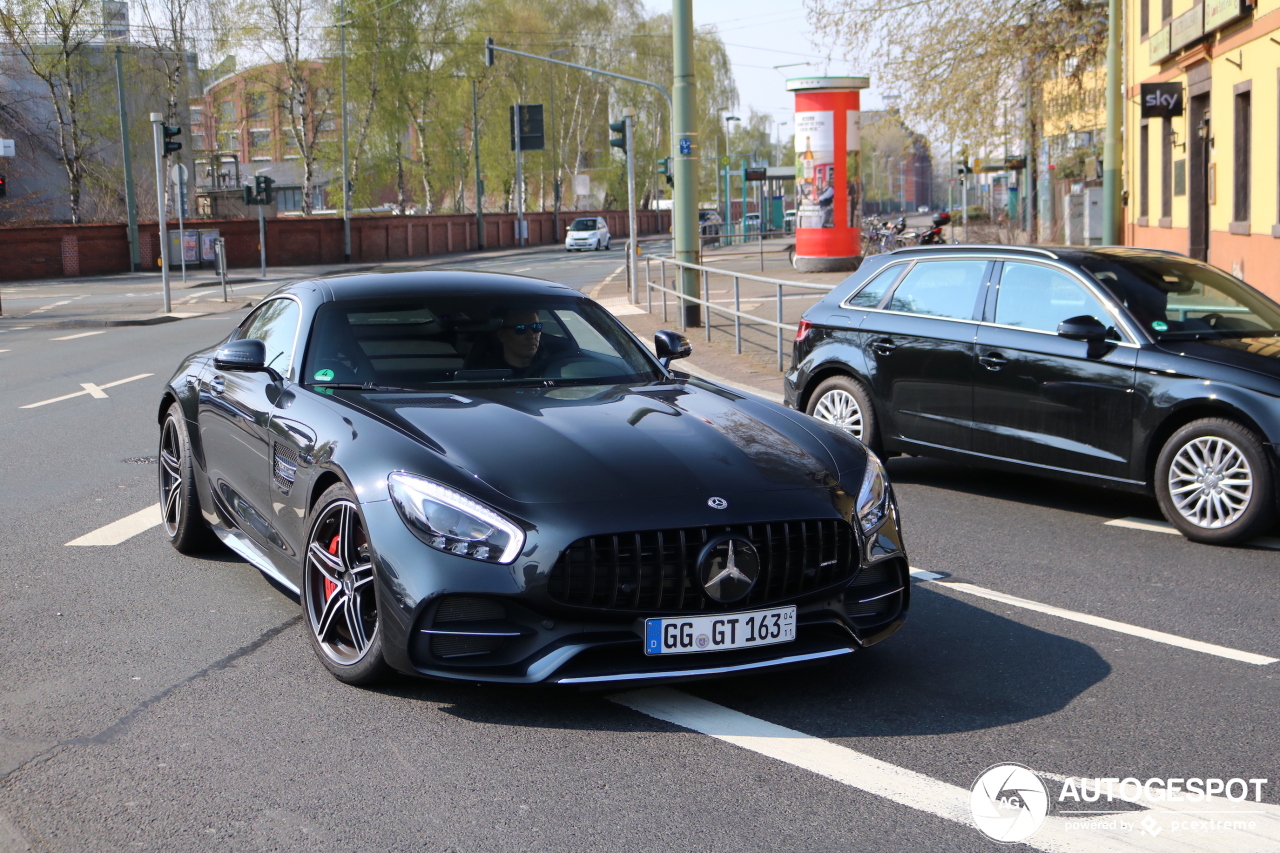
[645,0,882,147]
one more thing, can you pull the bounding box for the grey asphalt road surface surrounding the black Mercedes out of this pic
[0,244,1280,853]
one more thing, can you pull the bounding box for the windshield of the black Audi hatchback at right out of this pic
[1080,256,1280,341]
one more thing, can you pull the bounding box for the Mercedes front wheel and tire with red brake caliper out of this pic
[301,483,390,685]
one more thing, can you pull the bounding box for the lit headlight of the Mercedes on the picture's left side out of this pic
[387,471,525,564]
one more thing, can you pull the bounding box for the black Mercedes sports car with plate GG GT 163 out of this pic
[159,272,909,684]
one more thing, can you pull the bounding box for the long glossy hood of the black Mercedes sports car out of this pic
[351,383,838,503]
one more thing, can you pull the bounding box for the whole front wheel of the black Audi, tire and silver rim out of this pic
[1155,418,1275,544]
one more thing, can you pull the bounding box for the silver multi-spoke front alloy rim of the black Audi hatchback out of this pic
[1169,435,1253,530]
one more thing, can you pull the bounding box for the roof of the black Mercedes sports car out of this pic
[281,270,586,301]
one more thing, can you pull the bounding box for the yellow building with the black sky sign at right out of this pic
[1124,0,1280,298]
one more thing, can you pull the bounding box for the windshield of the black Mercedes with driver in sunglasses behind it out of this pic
[303,293,663,389]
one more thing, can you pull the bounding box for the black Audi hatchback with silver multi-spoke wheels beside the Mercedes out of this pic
[786,246,1280,544]
